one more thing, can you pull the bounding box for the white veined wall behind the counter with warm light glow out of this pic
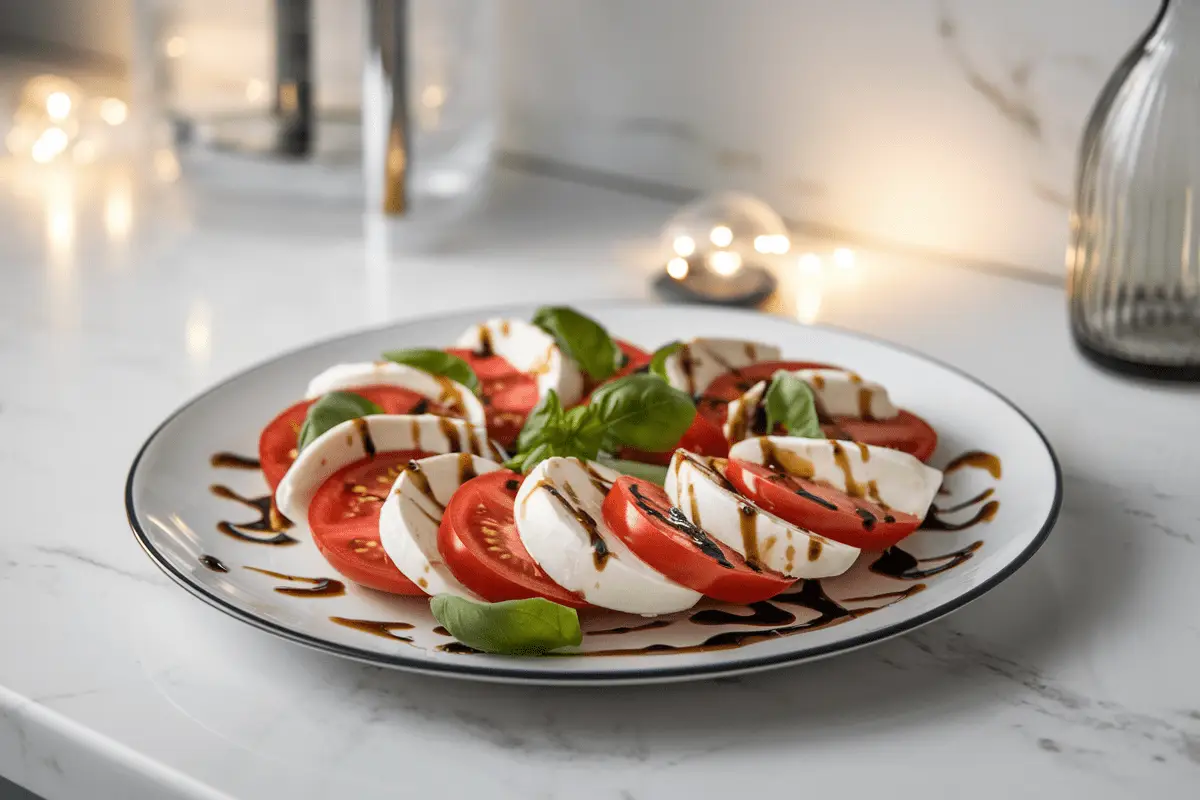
[0,0,1159,272]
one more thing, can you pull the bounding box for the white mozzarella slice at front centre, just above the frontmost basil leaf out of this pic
[515,457,700,615]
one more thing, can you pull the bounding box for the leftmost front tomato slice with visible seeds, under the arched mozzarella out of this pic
[308,450,431,595]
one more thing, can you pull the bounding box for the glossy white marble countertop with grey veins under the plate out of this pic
[0,158,1200,800]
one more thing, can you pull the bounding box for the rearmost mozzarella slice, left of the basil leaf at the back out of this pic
[457,319,583,407]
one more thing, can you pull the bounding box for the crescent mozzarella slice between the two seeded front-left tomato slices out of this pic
[379,452,500,600]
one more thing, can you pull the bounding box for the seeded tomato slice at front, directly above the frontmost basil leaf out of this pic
[438,469,587,608]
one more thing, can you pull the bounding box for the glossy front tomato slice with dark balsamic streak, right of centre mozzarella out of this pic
[604,475,796,603]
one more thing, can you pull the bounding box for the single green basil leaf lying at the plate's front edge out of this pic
[430,595,583,656]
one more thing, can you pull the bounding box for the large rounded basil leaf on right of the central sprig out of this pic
[589,373,696,452]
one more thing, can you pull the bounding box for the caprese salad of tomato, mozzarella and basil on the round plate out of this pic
[259,307,942,655]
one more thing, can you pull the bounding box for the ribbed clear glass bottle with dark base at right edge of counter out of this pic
[1068,0,1200,380]
